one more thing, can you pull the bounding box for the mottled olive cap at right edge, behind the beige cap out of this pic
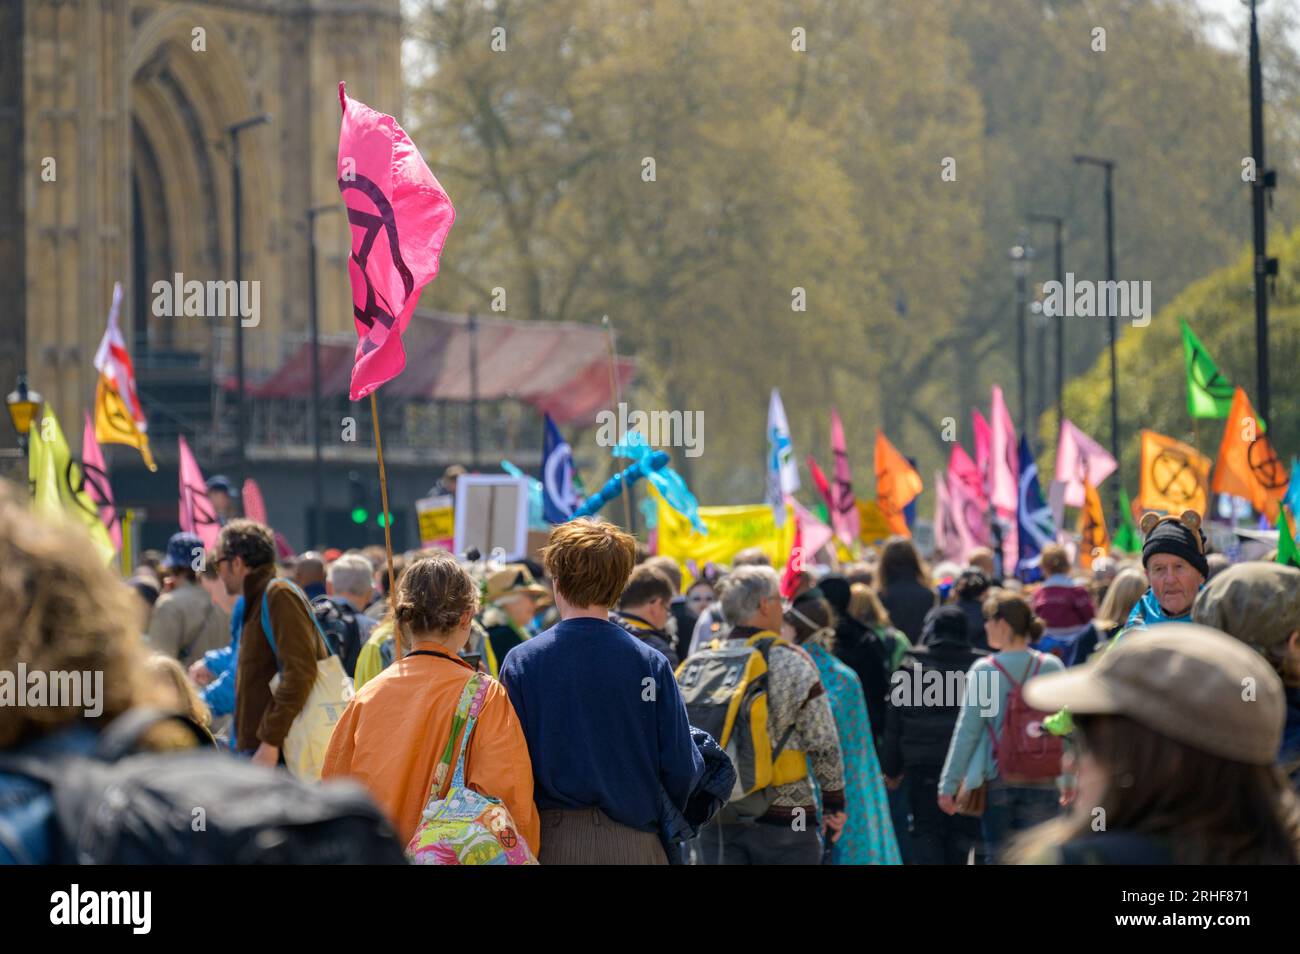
[1192,561,1300,649]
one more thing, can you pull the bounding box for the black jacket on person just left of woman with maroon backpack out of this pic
[880,641,988,776]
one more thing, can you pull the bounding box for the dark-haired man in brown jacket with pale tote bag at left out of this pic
[217,520,325,766]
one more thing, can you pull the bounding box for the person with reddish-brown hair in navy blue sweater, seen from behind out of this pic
[501,519,705,864]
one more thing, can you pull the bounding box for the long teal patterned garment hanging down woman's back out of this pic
[802,642,902,864]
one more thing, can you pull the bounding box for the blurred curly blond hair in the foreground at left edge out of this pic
[0,481,144,750]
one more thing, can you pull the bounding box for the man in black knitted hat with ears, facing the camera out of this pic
[1125,511,1210,632]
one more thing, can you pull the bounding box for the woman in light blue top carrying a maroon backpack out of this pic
[939,590,1065,858]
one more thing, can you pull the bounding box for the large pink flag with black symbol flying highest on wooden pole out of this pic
[338,83,456,400]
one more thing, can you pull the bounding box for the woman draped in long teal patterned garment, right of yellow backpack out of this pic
[781,589,902,864]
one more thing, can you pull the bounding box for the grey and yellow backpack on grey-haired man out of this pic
[677,632,807,821]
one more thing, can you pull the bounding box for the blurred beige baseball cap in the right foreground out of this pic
[1024,623,1286,766]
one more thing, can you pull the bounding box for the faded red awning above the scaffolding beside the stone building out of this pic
[236,312,636,424]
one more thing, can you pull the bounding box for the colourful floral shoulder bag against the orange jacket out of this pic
[406,665,537,864]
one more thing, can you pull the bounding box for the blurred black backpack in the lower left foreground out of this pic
[0,708,406,864]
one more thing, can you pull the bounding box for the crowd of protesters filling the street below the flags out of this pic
[0,470,1300,864]
